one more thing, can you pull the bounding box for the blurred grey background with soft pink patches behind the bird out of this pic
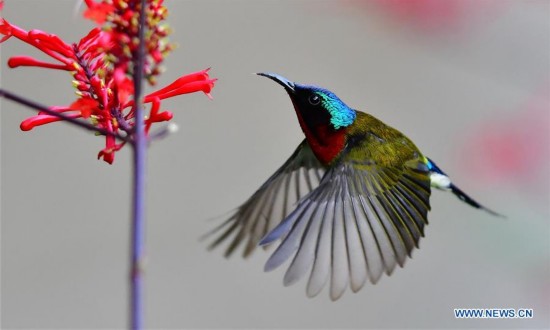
[0,0,550,328]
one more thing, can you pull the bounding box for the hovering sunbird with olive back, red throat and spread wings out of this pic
[207,72,501,301]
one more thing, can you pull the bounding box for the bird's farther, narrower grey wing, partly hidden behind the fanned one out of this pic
[207,140,325,257]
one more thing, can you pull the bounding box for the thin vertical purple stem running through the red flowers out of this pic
[130,0,147,330]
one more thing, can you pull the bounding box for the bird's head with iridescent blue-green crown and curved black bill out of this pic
[258,73,356,130]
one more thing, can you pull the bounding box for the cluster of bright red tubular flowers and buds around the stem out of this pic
[0,0,216,164]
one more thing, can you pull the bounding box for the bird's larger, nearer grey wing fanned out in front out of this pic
[260,159,430,300]
